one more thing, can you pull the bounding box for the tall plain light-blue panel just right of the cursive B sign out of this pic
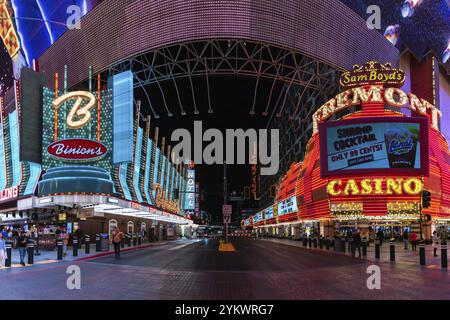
[111,71,134,164]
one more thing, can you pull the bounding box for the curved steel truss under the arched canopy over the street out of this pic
[107,39,337,119]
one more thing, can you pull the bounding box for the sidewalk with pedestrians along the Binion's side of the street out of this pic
[0,240,172,270]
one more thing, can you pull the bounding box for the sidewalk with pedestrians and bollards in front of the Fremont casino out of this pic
[259,238,448,269]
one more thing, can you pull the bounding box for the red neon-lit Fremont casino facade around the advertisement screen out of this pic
[243,61,450,238]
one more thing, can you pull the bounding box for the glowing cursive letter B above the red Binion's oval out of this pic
[53,91,96,129]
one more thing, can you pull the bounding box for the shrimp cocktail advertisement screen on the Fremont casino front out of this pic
[319,117,428,176]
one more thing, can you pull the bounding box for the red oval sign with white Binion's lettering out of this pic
[47,139,108,161]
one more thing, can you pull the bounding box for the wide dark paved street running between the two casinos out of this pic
[0,239,450,300]
